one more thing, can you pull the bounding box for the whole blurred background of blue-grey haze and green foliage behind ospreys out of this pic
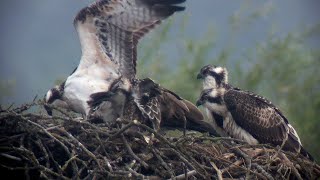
[0,0,320,158]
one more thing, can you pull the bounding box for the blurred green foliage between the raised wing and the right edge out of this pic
[138,12,320,161]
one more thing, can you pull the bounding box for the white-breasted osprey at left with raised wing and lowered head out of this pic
[45,0,185,119]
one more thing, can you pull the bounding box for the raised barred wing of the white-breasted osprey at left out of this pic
[74,0,185,79]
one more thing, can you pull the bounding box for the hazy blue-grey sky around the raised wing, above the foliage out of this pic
[0,0,320,103]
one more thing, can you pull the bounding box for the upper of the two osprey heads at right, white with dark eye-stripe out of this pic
[197,65,228,89]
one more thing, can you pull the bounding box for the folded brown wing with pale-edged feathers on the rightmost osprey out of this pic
[224,89,301,151]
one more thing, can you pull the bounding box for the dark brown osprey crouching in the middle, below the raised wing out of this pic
[90,78,217,135]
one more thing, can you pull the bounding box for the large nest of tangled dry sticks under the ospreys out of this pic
[0,101,320,179]
